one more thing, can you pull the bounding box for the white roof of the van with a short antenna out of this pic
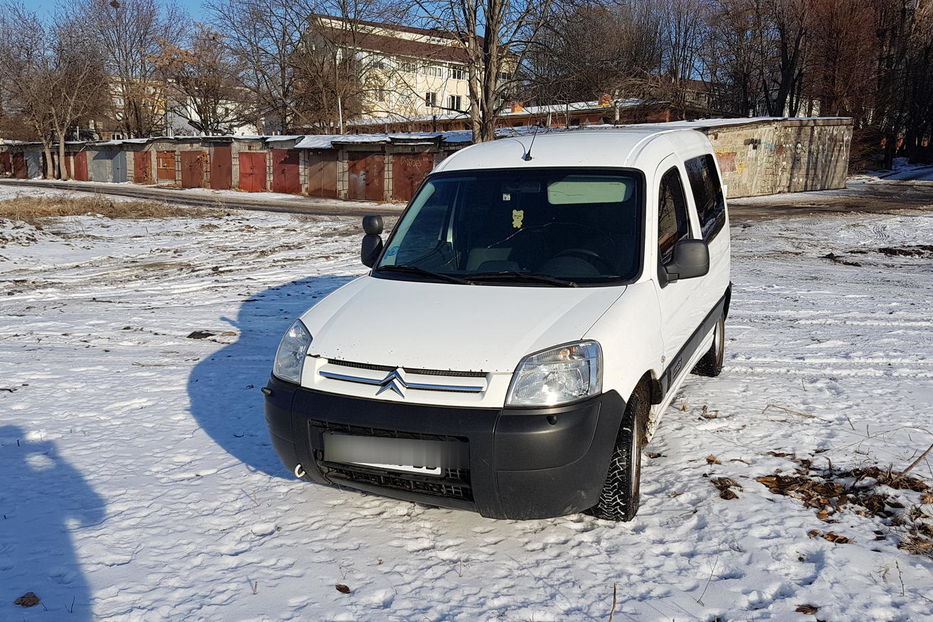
[434,126,712,172]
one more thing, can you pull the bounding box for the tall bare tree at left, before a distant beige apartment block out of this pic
[83,0,188,137]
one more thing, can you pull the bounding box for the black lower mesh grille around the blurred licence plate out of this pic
[309,421,473,501]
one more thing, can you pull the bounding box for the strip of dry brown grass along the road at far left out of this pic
[0,195,217,225]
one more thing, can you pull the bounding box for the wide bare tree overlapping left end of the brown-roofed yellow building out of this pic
[206,0,406,132]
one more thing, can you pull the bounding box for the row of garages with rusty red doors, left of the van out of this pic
[0,132,470,201]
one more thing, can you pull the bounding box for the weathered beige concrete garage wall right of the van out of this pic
[696,119,852,198]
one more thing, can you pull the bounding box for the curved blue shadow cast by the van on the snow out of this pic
[188,275,356,478]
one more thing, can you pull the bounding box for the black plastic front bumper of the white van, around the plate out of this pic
[266,377,625,519]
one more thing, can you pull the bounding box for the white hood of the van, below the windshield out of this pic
[301,276,625,373]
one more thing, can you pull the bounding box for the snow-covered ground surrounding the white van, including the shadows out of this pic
[0,193,933,621]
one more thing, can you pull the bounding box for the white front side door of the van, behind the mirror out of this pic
[654,156,708,390]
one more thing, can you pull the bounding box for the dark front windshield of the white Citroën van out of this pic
[374,169,644,286]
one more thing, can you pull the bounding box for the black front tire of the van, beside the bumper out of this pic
[589,385,651,521]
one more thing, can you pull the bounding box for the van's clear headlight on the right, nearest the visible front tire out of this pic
[505,341,602,406]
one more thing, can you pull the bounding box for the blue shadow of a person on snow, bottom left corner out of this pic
[0,425,105,622]
